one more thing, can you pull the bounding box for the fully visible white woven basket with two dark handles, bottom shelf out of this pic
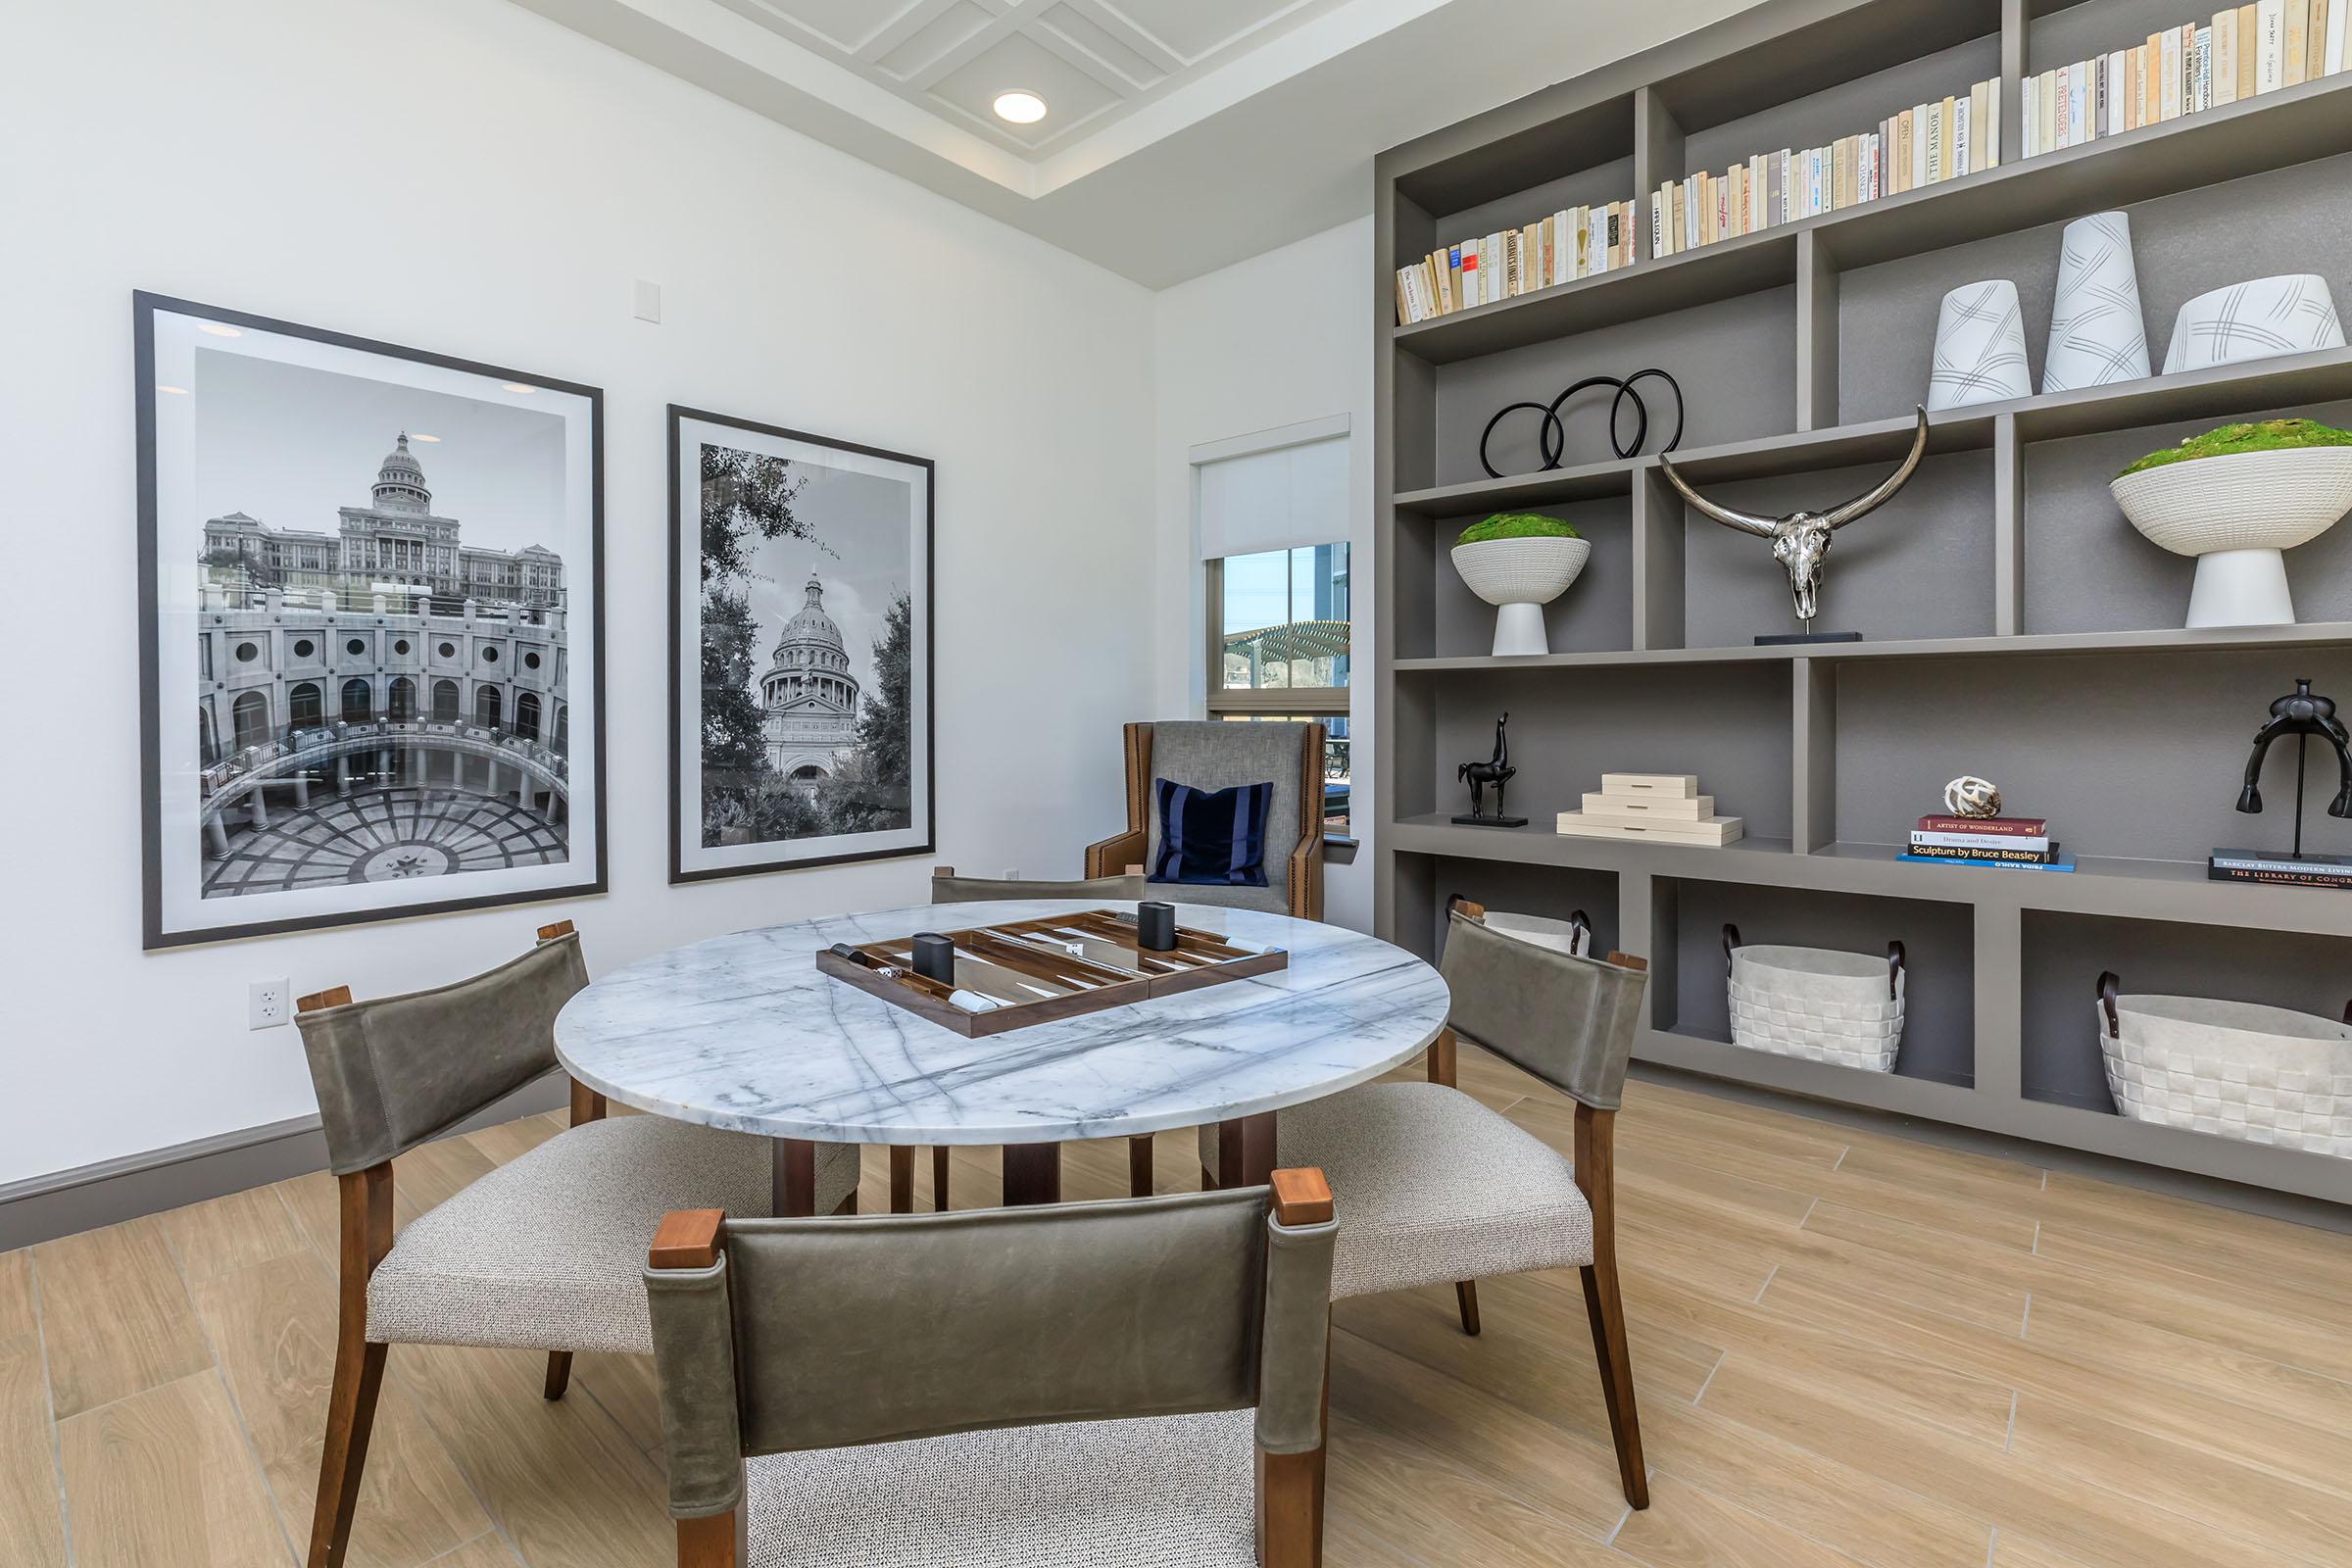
[1724,926,1905,1072]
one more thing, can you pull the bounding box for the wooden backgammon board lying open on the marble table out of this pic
[816,909,1292,1037]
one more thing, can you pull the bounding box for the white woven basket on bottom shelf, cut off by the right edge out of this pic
[2098,976,2352,1159]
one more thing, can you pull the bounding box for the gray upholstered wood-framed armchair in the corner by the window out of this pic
[1087,719,1324,919]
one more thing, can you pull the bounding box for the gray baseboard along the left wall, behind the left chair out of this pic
[0,1072,571,1253]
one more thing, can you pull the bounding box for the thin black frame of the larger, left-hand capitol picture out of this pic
[131,289,610,953]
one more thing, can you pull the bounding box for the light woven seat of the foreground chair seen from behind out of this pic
[738,1410,1258,1568]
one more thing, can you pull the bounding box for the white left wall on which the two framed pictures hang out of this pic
[0,0,1156,1183]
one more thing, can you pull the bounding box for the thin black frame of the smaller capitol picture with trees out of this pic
[668,402,939,886]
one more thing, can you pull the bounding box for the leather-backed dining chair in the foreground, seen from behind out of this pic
[645,1171,1334,1568]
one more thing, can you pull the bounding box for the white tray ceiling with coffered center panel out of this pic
[515,0,1768,289]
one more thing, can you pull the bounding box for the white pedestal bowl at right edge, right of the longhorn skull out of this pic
[2107,447,2352,627]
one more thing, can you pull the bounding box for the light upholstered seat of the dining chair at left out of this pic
[367,1116,858,1356]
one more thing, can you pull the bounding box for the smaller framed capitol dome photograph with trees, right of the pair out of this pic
[670,407,934,882]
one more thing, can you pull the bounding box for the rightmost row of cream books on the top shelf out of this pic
[2023,0,2352,158]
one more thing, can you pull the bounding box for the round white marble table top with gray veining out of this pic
[555,898,1448,1145]
